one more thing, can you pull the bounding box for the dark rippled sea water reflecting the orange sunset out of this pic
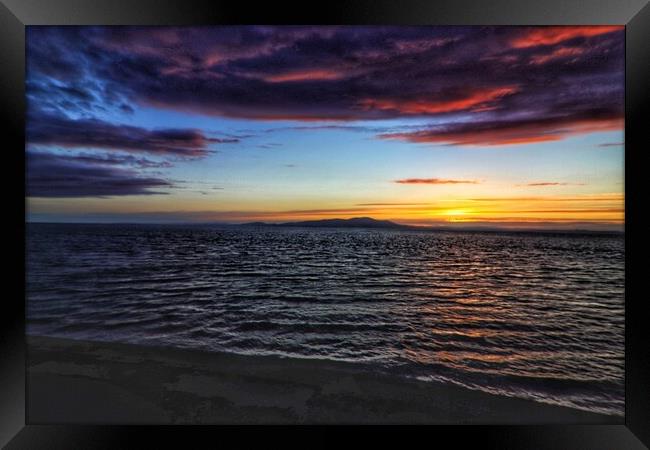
[26,224,625,415]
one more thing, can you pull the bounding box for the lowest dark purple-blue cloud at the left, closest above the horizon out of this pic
[27,151,172,197]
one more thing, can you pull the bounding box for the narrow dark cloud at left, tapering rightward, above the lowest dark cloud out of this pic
[27,115,230,157]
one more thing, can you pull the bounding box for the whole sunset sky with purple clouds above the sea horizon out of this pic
[26,26,625,229]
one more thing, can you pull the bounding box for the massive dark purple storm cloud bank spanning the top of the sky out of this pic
[27,26,624,145]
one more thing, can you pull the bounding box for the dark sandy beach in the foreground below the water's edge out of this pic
[27,336,623,424]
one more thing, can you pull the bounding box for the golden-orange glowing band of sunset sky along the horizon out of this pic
[83,192,625,227]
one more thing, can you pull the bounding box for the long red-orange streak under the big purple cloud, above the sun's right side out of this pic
[359,86,517,114]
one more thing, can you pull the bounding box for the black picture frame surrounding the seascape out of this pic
[0,0,650,449]
